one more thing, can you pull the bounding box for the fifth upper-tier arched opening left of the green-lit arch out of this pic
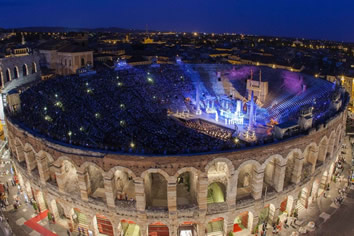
[61,160,79,194]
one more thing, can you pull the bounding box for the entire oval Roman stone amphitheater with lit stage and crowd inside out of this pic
[6,63,348,236]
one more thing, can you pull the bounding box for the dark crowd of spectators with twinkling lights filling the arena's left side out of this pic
[15,65,234,154]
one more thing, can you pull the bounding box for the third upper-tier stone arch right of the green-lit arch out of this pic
[284,148,302,187]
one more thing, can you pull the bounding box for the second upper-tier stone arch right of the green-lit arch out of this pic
[262,154,286,192]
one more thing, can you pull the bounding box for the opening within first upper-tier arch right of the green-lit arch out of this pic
[236,164,255,204]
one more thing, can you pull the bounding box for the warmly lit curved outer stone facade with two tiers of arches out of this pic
[7,109,346,236]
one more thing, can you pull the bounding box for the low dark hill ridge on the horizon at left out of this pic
[14,26,149,33]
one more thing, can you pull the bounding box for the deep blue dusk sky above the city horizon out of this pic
[0,0,354,42]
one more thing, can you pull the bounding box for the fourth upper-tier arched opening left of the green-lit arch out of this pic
[86,165,106,200]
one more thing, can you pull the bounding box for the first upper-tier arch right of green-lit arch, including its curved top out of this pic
[235,160,261,203]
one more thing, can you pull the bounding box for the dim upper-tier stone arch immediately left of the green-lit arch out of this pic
[174,167,200,208]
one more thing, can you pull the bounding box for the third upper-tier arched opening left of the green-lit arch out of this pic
[114,170,135,206]
